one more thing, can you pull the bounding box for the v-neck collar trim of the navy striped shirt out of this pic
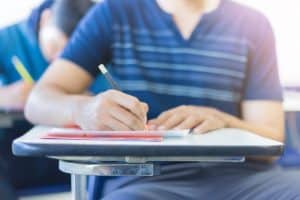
[152,0,226,45]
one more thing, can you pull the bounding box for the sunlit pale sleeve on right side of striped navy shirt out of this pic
[244,17,283,101]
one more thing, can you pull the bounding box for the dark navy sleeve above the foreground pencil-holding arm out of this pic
[60,1,112,77]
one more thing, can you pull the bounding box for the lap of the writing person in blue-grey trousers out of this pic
[103,163,300,200]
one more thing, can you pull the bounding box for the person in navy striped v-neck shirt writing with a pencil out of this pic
[26,0,300,200]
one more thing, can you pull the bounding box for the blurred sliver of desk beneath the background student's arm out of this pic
[0,108,25,129]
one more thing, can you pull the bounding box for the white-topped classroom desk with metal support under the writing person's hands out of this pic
[12,126,283,200]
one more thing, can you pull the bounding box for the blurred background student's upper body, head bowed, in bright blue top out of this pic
[0,0,96,108]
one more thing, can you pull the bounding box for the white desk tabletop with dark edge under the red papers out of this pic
[13,126,283,157]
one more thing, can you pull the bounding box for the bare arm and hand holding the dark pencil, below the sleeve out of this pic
[25,59,148,130]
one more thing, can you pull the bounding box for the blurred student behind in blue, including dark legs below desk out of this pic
[0,0,93,200]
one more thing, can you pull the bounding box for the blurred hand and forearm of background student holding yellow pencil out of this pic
[0,81,33,109]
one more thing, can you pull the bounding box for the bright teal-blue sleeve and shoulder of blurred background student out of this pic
[0,22,48,85]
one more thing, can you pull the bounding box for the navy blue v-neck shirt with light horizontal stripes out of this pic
[61,0,282,118]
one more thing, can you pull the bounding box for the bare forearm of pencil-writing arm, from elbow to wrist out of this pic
[25,86,91,126]
